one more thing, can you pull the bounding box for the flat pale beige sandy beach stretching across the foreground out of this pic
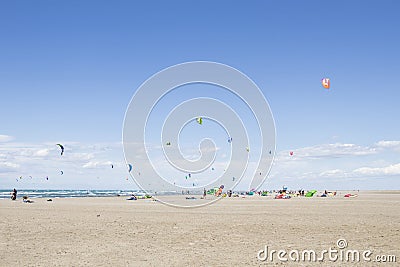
[0,191,400,266]
